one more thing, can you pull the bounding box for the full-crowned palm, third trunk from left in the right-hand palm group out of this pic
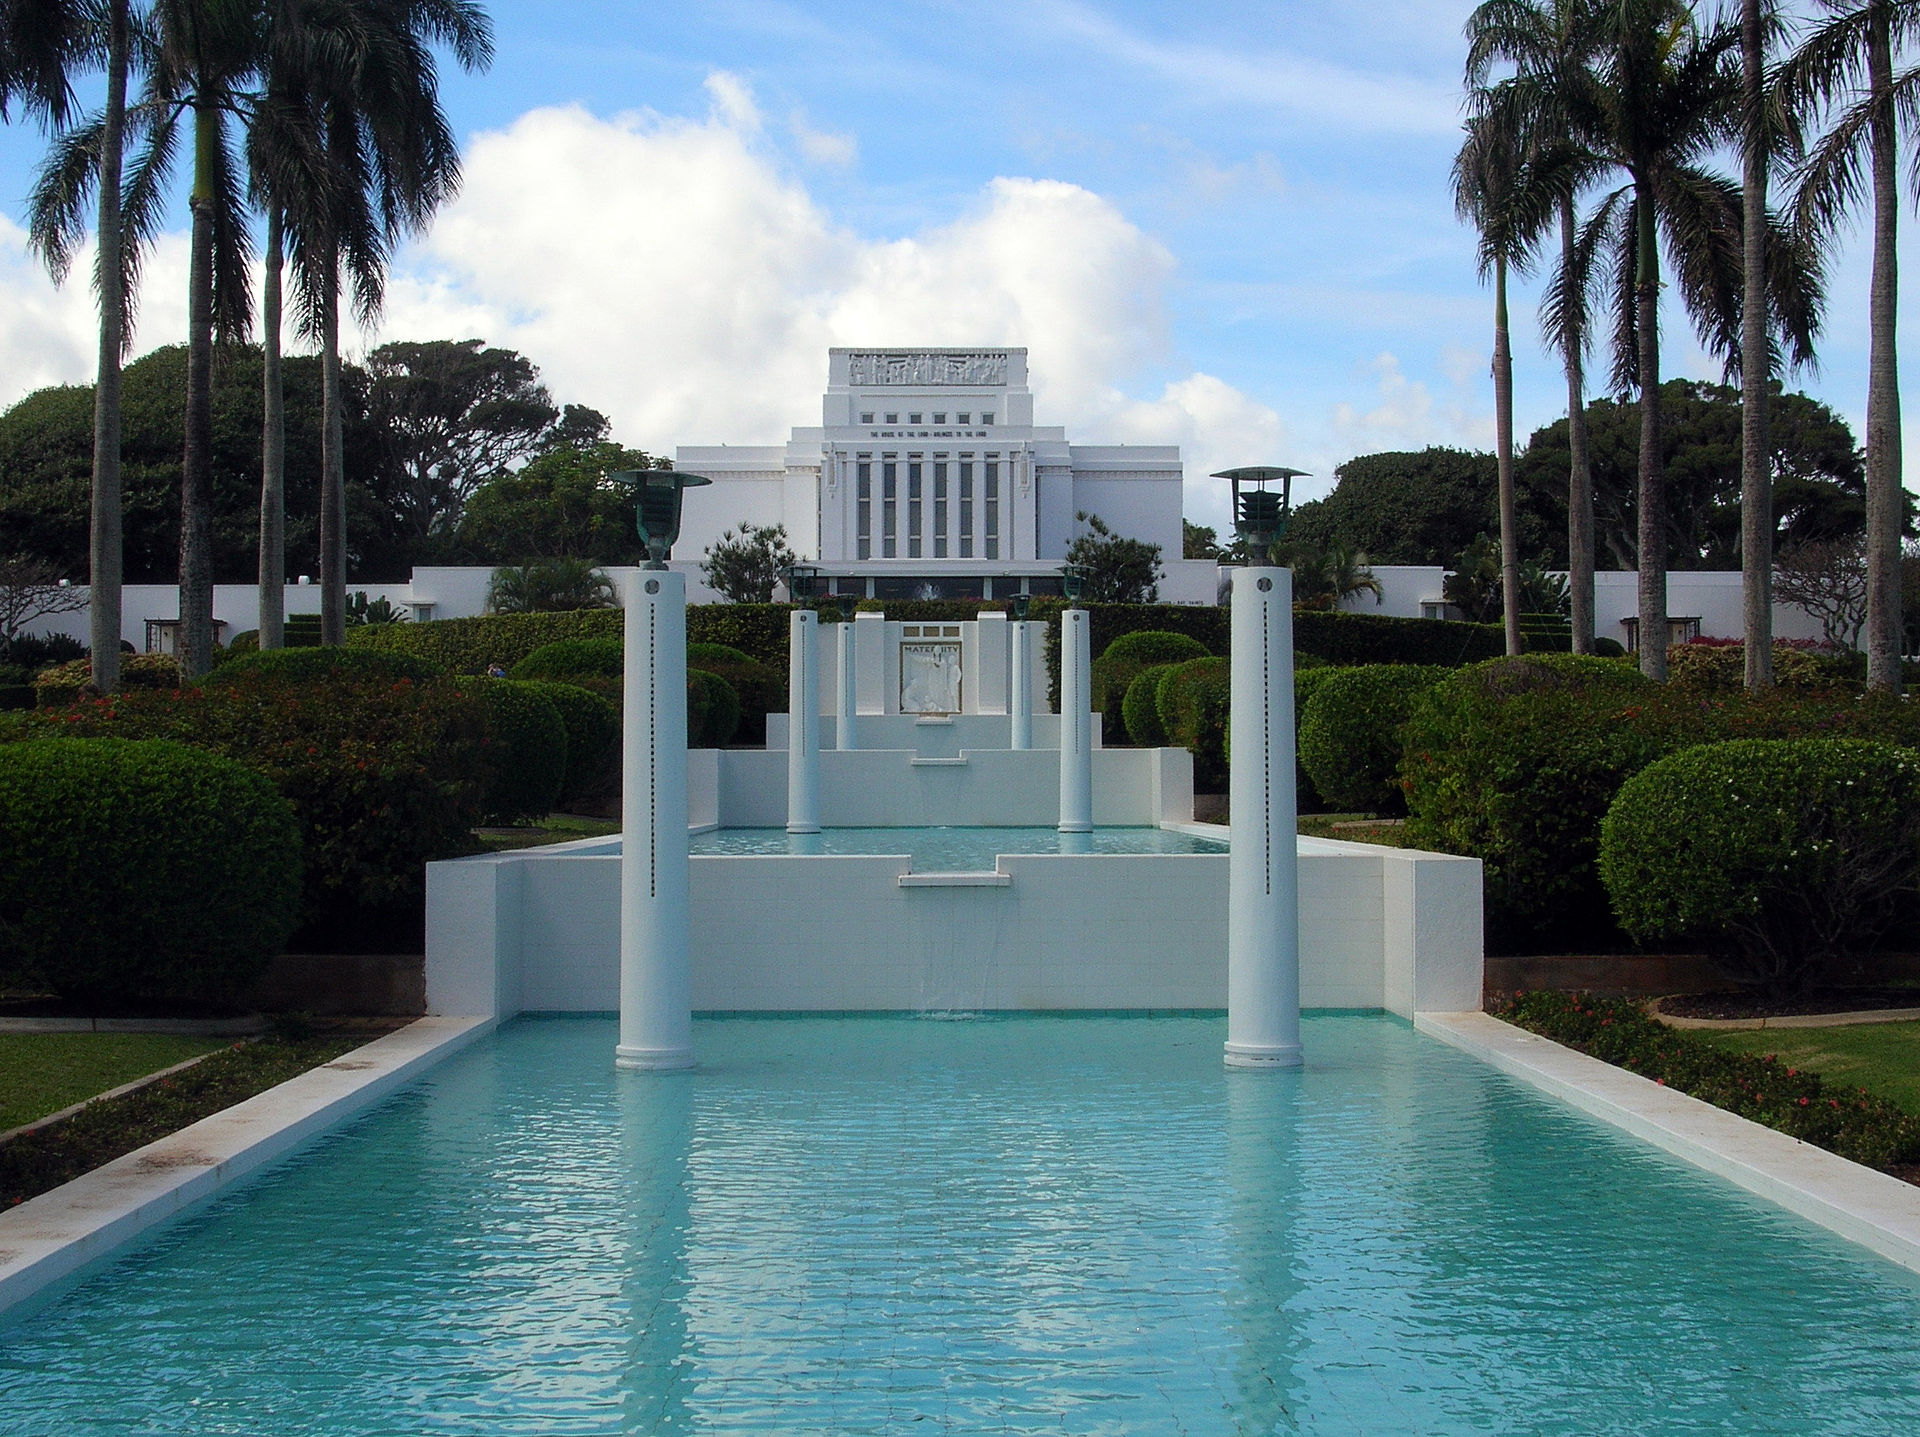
[1565,0,1822,678]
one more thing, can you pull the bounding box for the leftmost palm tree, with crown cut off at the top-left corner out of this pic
[0,0,134,694]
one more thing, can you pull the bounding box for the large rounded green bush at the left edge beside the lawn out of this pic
[0,738,301,1003]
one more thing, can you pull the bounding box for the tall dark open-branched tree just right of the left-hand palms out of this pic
[367,340,556,548]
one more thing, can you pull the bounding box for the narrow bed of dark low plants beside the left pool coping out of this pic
[0,1034,369,1208]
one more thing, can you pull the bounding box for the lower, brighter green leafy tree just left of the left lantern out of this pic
[459,439,660,565]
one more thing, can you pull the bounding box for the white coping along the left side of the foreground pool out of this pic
[0,1018,493,1312]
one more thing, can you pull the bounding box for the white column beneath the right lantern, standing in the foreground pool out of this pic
[1227,569,1300,1068]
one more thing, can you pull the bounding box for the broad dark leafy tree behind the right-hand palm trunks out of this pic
[1519,378,1864,569]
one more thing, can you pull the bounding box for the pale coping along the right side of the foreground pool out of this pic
[1413,1012,1920,1272]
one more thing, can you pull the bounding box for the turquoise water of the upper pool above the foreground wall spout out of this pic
[691,828,1227,872]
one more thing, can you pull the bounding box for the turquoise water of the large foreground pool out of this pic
[0,1016,1920,1437]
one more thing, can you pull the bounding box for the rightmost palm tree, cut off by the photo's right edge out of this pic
[1778,0,1920,694]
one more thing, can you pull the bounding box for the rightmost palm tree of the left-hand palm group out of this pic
[282,0,493,644]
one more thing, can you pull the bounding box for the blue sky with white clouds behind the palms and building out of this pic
[0,0,1920,534]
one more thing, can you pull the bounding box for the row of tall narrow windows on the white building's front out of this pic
[854,455,1000,559]
